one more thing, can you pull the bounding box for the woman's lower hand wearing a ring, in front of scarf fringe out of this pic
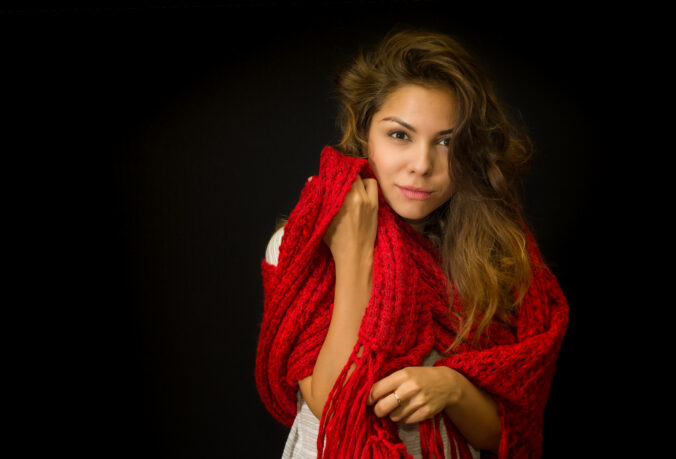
[367,366,461,424]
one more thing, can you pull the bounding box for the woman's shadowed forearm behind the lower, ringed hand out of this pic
[440,367,501,454]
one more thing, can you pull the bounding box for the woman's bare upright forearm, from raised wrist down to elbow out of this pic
[300,257,373,418]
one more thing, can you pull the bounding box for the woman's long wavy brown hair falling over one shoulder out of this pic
[336,29,532,352]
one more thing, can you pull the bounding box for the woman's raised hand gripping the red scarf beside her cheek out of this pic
[324,176,378,266]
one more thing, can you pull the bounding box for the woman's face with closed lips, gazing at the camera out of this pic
[368,85,457,231]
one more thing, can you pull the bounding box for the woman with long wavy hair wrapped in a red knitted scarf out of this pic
[256,27,568,457]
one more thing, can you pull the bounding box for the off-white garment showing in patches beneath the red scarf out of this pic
[265,228,480,459]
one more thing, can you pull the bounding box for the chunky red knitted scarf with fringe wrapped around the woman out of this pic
[256,147,568,458]
